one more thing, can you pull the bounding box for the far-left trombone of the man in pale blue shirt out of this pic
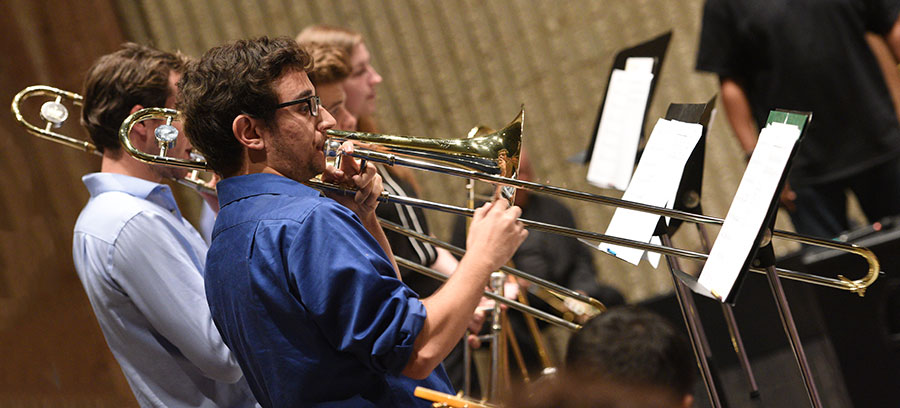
[12,85,215,193]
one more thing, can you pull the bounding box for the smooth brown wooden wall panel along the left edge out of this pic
[0,0,143,407]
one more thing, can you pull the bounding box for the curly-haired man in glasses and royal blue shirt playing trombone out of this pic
[179,37,527,407]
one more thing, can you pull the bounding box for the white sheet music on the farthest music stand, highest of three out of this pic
[587,58,653,190]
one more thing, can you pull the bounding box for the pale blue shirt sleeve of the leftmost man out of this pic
[112,213,242,383]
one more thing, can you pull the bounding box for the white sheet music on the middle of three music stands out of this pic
[597,119,703,268]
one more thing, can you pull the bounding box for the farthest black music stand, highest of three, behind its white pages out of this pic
[568,31,672,164]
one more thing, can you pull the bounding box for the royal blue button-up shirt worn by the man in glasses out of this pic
[206,174,453,407]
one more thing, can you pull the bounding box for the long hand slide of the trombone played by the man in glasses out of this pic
[314,147,880,296]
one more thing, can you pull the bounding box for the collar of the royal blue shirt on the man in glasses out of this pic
[216,173,319,208]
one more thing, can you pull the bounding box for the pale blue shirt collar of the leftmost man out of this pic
[81,173,181,218]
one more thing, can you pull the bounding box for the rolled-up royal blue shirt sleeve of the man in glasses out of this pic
[288,203,426,373]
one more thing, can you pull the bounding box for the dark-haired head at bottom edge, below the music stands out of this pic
[566,306,697,395]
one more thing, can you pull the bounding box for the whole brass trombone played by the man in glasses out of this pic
[119,108,880,298]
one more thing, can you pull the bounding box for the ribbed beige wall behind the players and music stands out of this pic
[120,0,800,301]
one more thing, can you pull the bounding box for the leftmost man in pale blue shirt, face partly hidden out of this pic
[73,44,256,407]
